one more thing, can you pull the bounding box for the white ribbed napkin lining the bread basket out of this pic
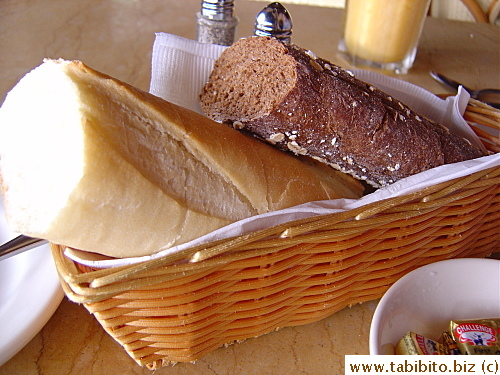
[66,33,500,268]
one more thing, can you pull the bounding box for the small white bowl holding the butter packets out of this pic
[370,259,500,355]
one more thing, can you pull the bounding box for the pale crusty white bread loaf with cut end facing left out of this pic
[0,60,362,257]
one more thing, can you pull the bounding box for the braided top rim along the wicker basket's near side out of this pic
[55,167,500,287]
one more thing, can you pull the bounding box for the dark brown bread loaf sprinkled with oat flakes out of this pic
[200,37,483,187]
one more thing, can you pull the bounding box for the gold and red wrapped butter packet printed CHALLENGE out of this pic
[449,319,500,355]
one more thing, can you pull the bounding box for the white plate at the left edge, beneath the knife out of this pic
[0,198,63,366]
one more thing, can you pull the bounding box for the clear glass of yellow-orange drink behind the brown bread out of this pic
[339,0,430,74]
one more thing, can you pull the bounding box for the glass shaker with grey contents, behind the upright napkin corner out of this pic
[196,0,239,46]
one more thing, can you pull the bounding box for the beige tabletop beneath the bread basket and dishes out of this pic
[0,0,500,375]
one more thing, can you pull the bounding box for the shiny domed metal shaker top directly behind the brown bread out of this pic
[254,2,292,43]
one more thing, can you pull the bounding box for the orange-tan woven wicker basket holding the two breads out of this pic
[51,101,500,369]
